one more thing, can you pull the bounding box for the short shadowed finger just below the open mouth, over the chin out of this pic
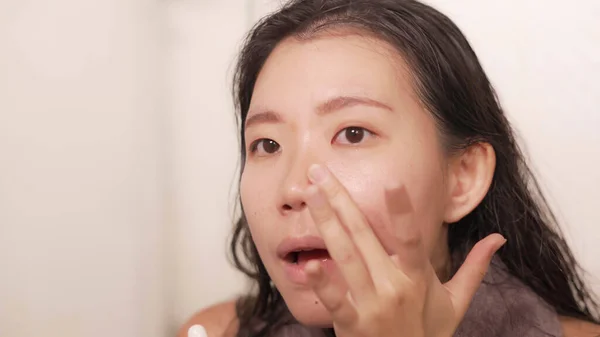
[304,260,358,325]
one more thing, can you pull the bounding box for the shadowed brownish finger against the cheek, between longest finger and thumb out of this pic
[385,186,431,278]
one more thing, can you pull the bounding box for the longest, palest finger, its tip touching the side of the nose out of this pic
[309,165,393,279]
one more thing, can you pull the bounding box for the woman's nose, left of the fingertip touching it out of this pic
[279,152,310,214]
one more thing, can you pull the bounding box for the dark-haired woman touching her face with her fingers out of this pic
[182,0,600,337]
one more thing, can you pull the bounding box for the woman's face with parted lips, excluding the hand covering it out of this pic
[241,35,447,326]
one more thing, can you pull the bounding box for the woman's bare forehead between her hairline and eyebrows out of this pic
[251,34,413,110]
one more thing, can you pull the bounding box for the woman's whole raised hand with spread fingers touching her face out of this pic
[305,165,506,337]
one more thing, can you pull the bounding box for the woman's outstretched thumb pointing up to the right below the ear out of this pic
[445,234,506,318]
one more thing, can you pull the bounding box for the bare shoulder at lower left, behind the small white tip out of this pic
[177,301,238,337]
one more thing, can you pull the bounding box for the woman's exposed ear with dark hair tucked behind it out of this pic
[444,143,496,223]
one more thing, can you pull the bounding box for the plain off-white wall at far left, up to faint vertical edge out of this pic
[0,0,165,337]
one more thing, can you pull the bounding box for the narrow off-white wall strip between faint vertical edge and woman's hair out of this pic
[167,0,249,327]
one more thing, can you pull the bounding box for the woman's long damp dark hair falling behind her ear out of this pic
[231,0,599,336]
